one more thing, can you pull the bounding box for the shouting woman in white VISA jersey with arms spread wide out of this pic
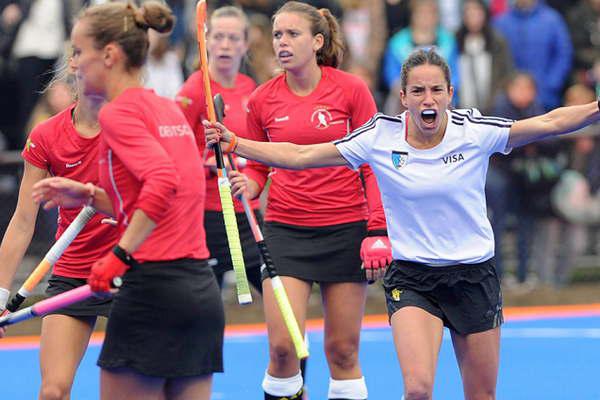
[205,50,600,400]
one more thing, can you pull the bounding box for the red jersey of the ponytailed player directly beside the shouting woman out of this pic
[246,67,385,229]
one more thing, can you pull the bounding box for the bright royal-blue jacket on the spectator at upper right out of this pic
[495,0,573,110]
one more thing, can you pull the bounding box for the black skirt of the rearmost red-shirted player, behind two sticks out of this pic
[204,211,262,274]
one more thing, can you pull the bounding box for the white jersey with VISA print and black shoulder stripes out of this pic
[334,109,513,266]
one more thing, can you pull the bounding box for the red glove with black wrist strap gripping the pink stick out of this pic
[87,245,135,292]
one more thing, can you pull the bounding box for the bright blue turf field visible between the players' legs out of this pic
[0,316,600,400]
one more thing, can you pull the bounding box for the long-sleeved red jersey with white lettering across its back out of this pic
[99,88,208,262]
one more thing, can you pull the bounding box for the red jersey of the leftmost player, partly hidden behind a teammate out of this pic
[21,105,118,278]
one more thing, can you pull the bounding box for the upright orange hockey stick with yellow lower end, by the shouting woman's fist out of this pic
[196,0,252,304]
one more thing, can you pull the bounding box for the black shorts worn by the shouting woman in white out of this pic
[383,259,504,335]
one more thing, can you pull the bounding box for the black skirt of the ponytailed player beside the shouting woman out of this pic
[263,221,367,282]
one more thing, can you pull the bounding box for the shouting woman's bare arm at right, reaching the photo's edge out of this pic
[507,101,600,148]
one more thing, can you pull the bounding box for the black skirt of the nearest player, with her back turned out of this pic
[98,259,225,378]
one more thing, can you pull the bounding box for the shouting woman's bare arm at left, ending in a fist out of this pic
[203,121,349,169]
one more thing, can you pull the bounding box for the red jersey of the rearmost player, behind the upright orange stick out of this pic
[175,71,266,212]
